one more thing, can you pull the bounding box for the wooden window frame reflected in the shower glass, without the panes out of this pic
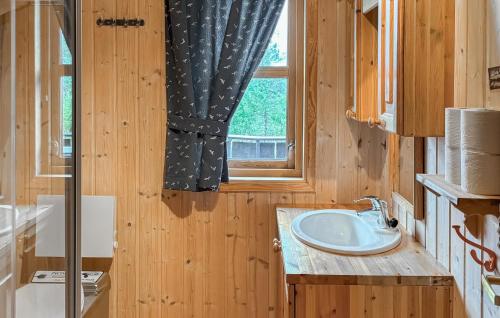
[31,5,72,178]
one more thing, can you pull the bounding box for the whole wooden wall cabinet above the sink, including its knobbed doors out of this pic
[347,0,455,137]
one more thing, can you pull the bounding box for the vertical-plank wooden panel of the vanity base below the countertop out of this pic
[295,285,451,318]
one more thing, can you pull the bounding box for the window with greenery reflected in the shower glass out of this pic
[32,6,73,176]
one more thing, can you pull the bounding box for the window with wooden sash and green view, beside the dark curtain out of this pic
[227,0,305,177]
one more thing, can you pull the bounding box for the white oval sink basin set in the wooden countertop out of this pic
[292,210,401,255]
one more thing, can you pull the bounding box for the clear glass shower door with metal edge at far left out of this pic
[0,0,83,318]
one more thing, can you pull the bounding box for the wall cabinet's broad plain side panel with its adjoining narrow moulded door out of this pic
[378,0,455,137]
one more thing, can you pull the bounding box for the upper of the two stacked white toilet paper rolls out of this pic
[461,108,500,155]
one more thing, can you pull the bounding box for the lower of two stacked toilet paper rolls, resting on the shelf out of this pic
[461,149,500,195]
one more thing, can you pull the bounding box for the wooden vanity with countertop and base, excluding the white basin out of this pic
[274,206,453,318]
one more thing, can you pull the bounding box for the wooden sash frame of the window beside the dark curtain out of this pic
[228,0,306,181]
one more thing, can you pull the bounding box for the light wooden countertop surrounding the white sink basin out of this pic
[276,205,453,286]
